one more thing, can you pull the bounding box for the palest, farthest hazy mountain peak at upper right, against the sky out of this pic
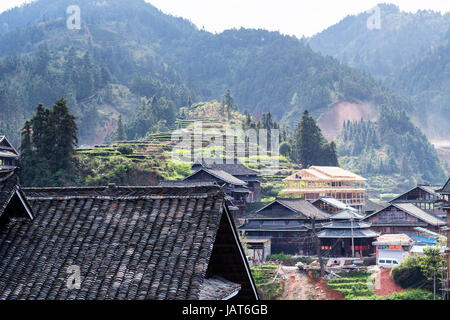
[308,4,450,78]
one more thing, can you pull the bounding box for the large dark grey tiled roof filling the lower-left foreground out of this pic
[0,186,257,300]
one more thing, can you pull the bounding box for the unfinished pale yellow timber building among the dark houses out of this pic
[283,166,366,206]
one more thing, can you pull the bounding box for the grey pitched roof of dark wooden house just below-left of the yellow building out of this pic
[249,199,329,220]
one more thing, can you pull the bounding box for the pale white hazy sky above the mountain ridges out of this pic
[0,0,450,37]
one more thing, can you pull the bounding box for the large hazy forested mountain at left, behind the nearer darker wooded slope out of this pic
[0,0,412,127]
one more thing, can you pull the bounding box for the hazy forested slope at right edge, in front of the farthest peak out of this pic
[390,30,450,139]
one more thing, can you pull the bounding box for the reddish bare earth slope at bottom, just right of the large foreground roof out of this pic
[281,267,345,300]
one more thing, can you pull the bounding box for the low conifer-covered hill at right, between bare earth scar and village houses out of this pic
[337,106,445,186]
